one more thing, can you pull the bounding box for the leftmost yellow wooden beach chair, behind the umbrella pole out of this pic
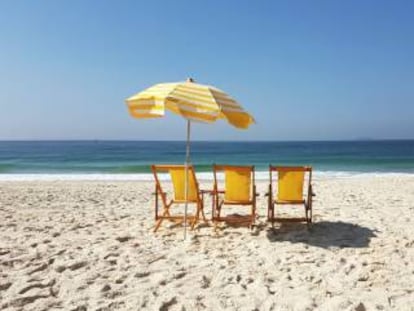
[151,165,207,232]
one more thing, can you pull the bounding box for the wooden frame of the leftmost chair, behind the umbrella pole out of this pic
[151,165,207,232]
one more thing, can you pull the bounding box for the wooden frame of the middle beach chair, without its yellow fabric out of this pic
[211,164,258,228]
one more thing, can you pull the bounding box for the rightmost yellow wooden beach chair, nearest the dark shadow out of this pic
[266,165,314,225]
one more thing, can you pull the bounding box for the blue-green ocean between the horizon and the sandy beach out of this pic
[0,140,414,180]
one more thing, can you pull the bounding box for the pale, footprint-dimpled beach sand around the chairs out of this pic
[0,175,414,311]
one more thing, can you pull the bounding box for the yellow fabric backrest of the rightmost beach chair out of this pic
[269,166,312,202]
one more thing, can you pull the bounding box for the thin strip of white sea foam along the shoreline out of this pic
[0,171,414,181]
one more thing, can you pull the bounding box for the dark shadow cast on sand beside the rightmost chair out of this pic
[267,221,376,248]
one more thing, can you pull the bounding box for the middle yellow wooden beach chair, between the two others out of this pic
[212,165,257,228]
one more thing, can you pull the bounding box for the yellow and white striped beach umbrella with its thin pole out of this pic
[126,78,255,238]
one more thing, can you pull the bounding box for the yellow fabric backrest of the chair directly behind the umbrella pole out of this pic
[151,165,199,202]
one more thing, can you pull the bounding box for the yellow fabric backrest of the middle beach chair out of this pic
[213,165,254,202]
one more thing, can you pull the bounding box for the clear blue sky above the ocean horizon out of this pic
[0,0,414,140]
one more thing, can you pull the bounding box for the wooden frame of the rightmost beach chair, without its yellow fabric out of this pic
[266,165,315,226]
